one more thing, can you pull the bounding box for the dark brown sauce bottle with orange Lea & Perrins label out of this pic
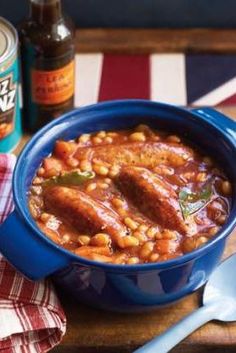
[19,0,75,132]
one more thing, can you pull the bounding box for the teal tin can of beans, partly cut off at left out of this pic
[0,17,22,152]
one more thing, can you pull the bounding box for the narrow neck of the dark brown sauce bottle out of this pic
[30,0,62,24]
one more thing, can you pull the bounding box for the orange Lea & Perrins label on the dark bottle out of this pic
[32,61,74,105]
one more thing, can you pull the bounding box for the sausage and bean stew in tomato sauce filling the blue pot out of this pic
[29,125,232,265]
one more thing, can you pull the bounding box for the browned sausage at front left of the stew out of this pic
[44,186,127,244]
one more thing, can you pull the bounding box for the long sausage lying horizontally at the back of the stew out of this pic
[75,142,193,168]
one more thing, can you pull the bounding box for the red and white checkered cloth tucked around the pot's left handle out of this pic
[0,154,66,353]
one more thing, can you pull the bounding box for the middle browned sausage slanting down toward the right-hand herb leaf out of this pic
[117,167,187,234]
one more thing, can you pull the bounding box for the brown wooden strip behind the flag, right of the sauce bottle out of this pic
[76,28,236,54]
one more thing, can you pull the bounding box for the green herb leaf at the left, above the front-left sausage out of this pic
[43,171,95,186]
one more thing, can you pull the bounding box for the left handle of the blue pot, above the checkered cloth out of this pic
[0,211,70,281]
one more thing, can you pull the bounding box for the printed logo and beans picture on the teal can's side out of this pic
[0,73,17,139]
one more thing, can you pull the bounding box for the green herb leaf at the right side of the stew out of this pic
[179,184,213,219]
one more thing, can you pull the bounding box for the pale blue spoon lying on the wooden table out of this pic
[134,254,236,353]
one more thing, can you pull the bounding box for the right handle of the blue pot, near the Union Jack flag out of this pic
[191,108,236,144]
